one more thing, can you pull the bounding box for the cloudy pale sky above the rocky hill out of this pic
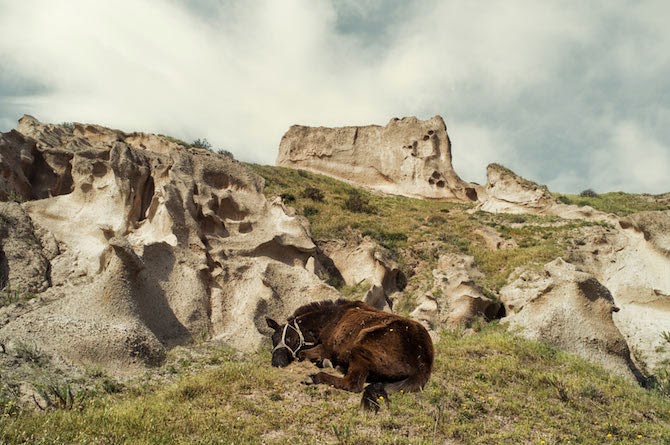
[0,0,670,194]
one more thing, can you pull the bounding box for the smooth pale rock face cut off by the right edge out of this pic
[569,211,670,372]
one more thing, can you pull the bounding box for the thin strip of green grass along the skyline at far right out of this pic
[554,192,670,216]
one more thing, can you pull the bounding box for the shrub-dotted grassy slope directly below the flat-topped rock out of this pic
[249,165,604,294]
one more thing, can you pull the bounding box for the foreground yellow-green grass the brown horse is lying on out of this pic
[0,326,670,444]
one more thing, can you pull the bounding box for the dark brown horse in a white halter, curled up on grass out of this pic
[266,300,433,412]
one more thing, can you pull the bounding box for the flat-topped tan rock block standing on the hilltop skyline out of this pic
[277,116,477,201]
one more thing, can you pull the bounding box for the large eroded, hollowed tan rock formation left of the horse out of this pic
[0,116,336,370]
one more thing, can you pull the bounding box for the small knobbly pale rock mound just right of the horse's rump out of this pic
[411,253,500,330]
